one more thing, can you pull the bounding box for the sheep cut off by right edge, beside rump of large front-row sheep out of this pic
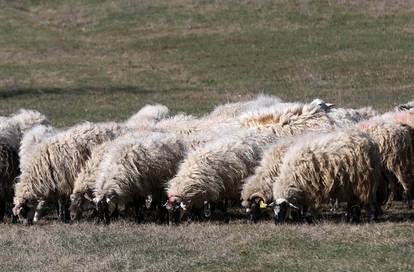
[357,117,414,206]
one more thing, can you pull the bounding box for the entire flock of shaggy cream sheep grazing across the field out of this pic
[0,95,414,224]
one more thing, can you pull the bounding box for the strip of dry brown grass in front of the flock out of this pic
[0,218,414,271]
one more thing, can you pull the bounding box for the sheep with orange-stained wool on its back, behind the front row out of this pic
[240,103,334,137]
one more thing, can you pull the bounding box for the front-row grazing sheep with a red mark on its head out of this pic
[166,130,276,223]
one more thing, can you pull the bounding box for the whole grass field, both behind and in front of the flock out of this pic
[0,0,414,271]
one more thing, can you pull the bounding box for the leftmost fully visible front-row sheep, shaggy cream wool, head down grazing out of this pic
[13,122,125,223]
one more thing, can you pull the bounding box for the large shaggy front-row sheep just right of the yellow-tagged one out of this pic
[271,129,381,222]
